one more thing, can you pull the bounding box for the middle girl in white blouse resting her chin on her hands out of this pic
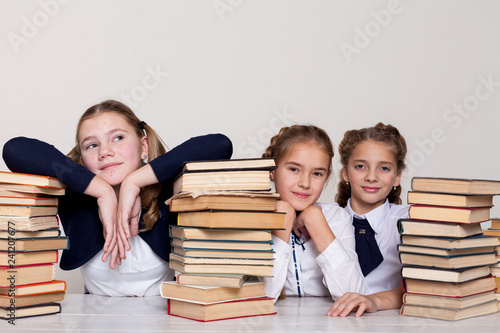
[261,125,365,300]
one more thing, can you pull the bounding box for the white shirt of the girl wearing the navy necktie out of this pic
[345,199,409,295]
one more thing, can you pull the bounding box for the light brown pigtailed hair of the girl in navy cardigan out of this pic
[67,100,166,231]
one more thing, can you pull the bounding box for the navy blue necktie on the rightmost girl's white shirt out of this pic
[352,216,384,276]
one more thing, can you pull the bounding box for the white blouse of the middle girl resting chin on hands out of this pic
[260,203,366,302]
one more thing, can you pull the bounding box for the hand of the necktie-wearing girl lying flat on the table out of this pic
[326,293,378,317]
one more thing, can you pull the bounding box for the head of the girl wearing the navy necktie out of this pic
[335,123,407,214]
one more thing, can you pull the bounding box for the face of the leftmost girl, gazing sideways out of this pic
[78,112,148,186]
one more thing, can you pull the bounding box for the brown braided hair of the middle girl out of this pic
[262,125,333,169]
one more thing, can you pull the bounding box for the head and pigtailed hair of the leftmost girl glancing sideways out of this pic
[68,100,166,230]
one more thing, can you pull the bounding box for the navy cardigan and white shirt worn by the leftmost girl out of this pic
[3,134,232,296]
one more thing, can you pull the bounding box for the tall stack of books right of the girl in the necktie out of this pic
[398,177,500,320]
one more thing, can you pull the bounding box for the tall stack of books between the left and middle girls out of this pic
[161,159,284,321]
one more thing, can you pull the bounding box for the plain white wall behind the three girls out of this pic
[0,0,500,292]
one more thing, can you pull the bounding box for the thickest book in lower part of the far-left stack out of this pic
[0,264,55,287]
